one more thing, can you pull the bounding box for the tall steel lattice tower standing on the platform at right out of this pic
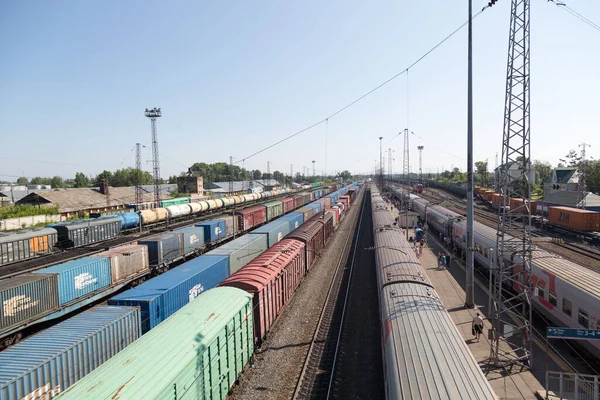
[490,0,533,367]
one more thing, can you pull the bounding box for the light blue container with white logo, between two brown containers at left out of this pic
[33,257,111,305]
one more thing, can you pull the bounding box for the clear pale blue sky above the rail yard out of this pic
[0,0,600,180]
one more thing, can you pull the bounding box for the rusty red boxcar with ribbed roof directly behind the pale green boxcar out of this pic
[219,239,306,343]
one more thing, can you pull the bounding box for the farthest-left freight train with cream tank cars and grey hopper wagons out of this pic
[0,183,326,266]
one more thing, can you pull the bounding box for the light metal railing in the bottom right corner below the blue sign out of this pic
[546,371,600,400]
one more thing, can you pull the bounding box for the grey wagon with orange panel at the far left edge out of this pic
[0,228,58,265]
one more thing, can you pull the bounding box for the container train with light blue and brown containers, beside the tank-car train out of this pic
[0,183,350,348]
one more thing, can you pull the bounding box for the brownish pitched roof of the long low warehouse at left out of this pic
[17,187,168,213]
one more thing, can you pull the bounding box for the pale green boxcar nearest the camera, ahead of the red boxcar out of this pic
[58,287,254,400]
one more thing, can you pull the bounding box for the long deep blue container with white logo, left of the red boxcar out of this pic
[108,255,229,333]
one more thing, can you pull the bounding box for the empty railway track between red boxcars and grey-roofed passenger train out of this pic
[292,189,366,399]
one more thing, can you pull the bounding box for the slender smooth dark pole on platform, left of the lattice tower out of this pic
[464,0,475,308]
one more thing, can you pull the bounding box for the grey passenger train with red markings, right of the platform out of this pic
[411,195,600,358]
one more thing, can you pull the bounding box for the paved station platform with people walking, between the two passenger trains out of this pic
[409,223,545,399]
